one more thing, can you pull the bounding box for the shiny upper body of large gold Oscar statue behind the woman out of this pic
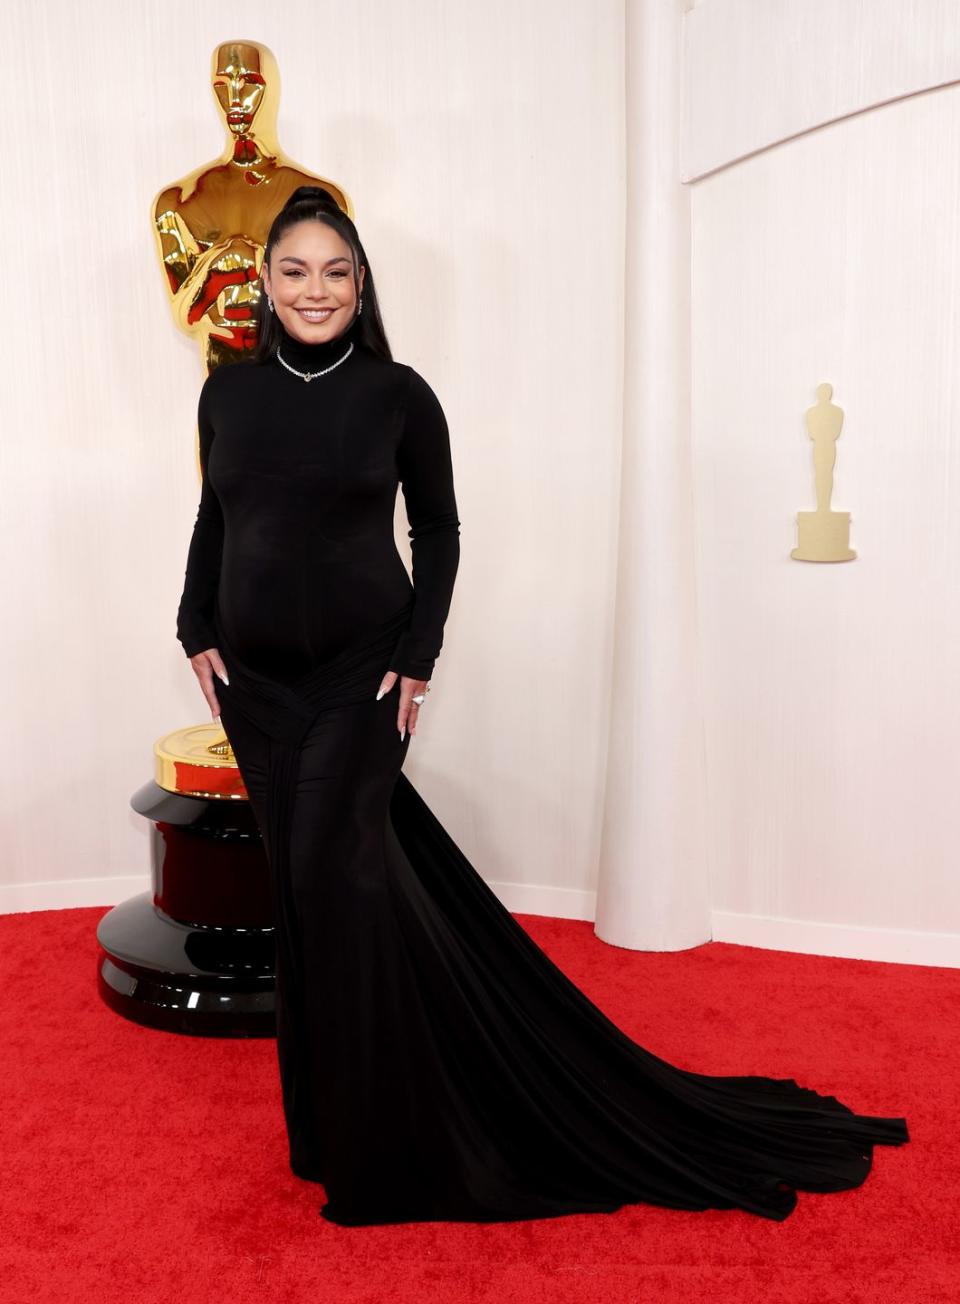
[153,40,355,373]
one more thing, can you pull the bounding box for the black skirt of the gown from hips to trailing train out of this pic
[211,605,908,1226]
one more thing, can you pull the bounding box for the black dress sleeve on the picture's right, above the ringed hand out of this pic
[389,368,460,679]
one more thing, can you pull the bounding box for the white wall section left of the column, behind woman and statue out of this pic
[0,0,623,914]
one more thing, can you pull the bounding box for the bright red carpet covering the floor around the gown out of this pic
[0,908,960,1304]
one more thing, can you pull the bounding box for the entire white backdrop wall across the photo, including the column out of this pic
[0,0,960,965]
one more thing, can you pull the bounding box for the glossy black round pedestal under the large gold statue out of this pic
[97,780,275,1037]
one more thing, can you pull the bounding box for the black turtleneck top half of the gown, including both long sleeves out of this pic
[179,323,459,681]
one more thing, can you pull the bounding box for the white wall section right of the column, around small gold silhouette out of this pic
[682,0,960,964]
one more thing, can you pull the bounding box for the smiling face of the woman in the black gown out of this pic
[262,220,367,344]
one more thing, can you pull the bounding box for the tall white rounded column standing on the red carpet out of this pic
[596,0,711,951]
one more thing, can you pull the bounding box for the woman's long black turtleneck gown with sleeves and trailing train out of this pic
[177,315,908,1226]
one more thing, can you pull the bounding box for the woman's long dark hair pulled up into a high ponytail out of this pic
[253,185,393,363]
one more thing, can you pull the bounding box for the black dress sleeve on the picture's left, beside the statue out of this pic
[176,377,223,657]
